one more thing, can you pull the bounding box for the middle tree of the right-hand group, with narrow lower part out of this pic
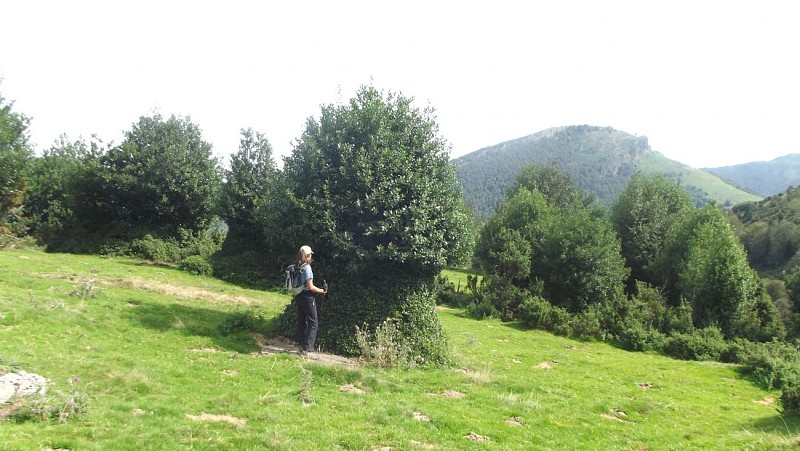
[612,174,695,292]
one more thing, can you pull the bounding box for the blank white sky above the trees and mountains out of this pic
[0,0,800,167]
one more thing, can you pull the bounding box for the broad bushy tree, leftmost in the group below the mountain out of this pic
[475,165,628,317]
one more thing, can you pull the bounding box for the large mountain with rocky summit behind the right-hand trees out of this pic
[452,125,761,217]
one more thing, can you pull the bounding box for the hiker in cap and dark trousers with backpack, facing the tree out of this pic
[294,246,327,353]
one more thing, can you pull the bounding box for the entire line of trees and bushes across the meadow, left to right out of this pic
[0,82,800,374]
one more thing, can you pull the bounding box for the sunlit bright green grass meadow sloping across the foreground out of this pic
[0,249,800,450]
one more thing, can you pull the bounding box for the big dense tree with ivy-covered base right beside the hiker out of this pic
[272,86,471,362]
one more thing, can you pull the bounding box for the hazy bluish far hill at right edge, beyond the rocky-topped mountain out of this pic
[703,154,800,196]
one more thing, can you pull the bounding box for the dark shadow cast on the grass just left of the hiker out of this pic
[128,302,268,353]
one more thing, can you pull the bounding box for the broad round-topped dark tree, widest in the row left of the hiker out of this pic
[103,114,220,237]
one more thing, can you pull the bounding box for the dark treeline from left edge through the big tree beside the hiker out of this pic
[0,86,474,364]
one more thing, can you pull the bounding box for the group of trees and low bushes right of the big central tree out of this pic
[454,162,800,411]
